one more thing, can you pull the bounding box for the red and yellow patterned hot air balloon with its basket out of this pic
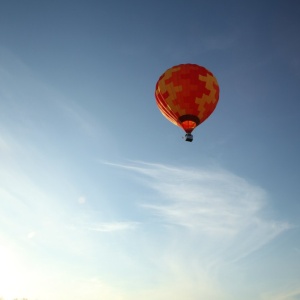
[155,64,219,142]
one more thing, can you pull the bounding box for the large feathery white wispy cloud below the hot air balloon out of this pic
[106,162,290,261]
